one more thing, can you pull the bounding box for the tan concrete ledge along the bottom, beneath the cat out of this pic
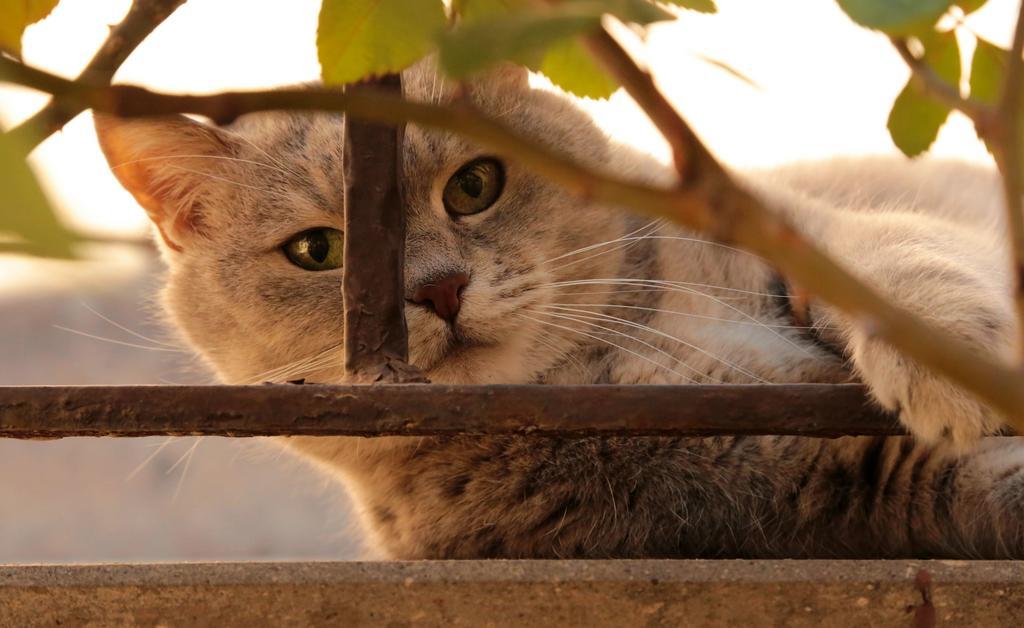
[0,560,1024,626]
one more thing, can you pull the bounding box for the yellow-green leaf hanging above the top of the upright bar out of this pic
[316,0,445,84]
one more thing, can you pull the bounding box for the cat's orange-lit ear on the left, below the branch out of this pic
[95,114,231,251]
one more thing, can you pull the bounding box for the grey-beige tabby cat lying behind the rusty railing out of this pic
[96,61,1024,559]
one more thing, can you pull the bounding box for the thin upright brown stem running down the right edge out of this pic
[989,2,1024,364]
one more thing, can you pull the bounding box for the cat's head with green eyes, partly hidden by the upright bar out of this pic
[97,65,647,383]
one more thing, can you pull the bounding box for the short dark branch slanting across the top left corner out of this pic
[8,0,185,151]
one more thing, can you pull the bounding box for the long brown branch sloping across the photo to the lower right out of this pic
[6,57,1024,428]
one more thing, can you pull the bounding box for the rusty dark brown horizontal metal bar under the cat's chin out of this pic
[0,384,903,438]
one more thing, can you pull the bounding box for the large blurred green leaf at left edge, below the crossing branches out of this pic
[0,131,75,258]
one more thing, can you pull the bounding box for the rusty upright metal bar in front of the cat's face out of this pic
[342,75,424,382]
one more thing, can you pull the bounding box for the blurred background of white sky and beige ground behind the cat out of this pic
[0,0,1017,562]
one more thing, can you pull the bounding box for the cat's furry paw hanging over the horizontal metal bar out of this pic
[850,337,1004,452]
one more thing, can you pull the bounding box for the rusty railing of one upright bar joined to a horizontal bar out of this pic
[0,75,903,438]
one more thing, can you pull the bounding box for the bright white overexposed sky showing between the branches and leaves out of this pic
[0,0,1017,281]
